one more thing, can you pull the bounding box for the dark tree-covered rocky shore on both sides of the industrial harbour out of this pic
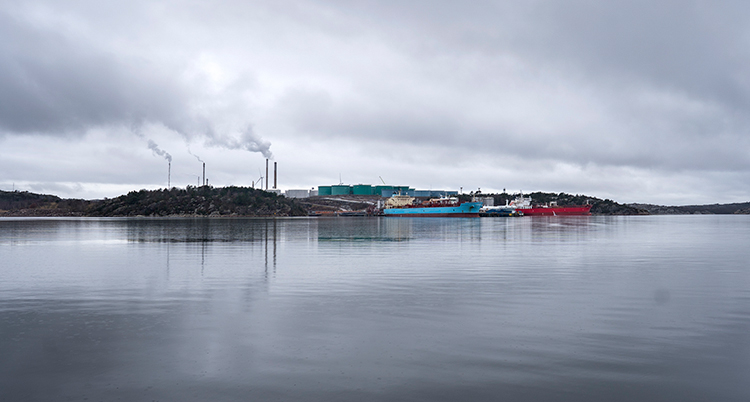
[0,186,750,217]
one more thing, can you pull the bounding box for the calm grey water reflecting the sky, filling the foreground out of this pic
[0,216,750,401]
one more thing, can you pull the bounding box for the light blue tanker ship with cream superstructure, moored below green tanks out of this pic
[383,194,482,218]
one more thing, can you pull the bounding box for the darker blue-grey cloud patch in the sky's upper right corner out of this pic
[534,1,750,107]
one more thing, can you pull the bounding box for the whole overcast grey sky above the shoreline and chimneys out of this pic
[0,0,750,205]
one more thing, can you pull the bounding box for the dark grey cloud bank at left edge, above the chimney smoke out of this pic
[0,12,185,135]
